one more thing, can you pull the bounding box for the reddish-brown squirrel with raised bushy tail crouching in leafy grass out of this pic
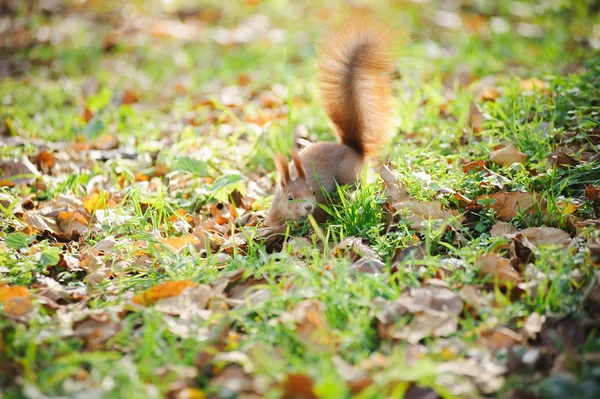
[265,15,394,226]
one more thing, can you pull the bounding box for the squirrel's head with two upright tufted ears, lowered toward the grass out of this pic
[266,152,317,226]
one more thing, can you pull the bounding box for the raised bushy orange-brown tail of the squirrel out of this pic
[319,15,398,158]
